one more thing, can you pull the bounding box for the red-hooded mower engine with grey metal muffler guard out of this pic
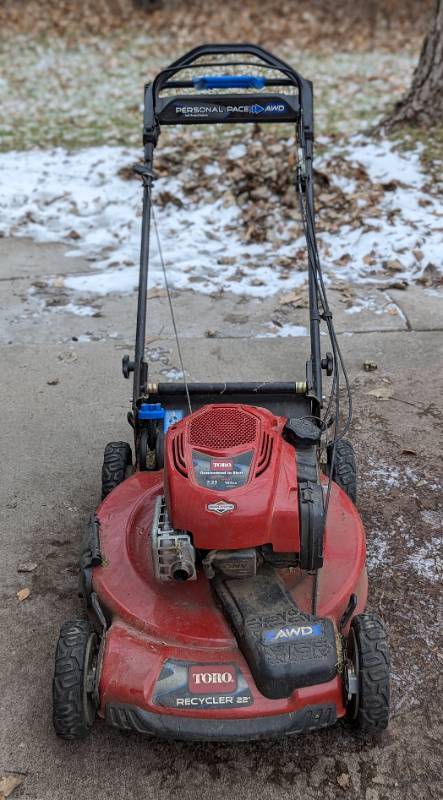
[152,405,300,581]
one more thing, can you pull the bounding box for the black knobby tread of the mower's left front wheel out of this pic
[52,619,94,739]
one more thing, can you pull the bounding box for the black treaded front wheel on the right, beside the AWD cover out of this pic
[346,614,390,735]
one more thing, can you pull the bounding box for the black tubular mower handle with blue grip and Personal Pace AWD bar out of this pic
[132,44,322,420]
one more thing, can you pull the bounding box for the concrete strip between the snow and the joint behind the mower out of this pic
[0,239,443,346]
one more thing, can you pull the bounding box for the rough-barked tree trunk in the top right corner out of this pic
[383,0,443,128]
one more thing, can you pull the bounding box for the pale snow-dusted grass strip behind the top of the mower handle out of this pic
[0,31,416,151]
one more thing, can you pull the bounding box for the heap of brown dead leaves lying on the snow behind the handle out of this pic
[156,126,388,253]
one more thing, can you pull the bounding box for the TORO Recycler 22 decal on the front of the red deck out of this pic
[153,659,253,711]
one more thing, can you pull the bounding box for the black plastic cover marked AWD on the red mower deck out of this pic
[212,565,337,699]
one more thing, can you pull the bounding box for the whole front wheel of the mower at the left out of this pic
[52,619,98,739]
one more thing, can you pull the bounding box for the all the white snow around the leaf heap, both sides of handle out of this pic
[0,137,443,310]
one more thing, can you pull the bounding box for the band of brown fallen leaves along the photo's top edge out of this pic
[0,0,433,54]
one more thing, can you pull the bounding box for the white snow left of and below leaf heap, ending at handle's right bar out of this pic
[0,147,306,297]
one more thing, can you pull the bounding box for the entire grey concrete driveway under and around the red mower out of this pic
[0,240,443,800]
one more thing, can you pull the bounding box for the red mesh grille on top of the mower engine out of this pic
[189,407,257,450]
